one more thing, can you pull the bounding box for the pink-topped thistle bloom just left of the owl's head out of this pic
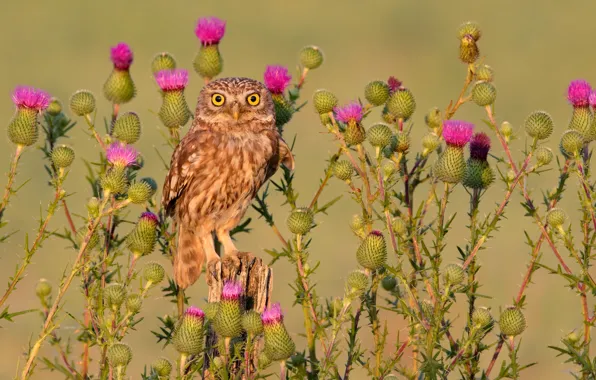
[155,69,191,129]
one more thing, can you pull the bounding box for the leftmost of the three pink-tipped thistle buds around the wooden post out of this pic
[172,306,205,356]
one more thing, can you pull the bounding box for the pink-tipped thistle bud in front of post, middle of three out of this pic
[213,281,242,338]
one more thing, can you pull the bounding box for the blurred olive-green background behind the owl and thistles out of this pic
[0,0,596,379]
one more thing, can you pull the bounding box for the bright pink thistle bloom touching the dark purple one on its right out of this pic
[434,120,474,183]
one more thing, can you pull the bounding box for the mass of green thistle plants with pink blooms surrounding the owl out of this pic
[0,17,596,380]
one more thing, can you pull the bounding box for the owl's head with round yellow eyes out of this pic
[195,78,275,130]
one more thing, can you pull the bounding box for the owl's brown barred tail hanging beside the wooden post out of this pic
[174,226,205,289]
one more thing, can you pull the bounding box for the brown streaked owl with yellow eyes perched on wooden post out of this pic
[162,78,294,288]
